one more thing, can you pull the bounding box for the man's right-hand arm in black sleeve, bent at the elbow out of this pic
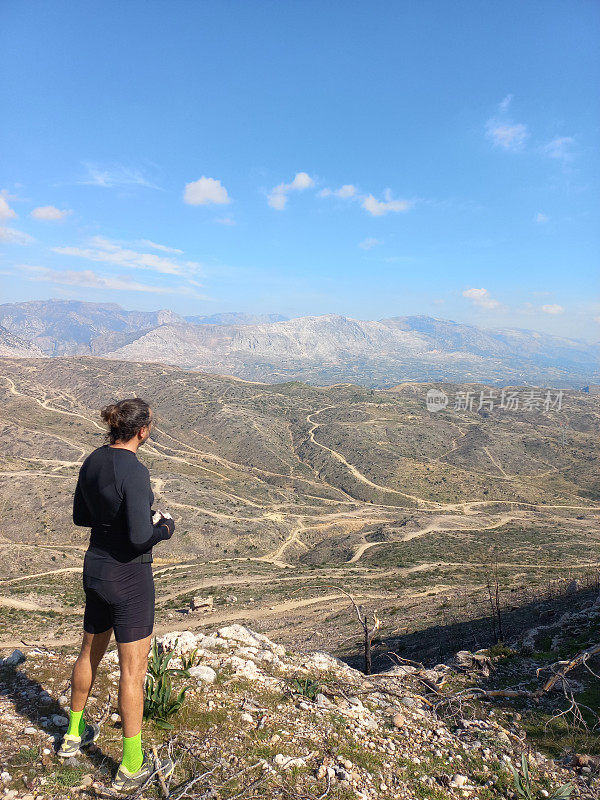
[122,469,175,553]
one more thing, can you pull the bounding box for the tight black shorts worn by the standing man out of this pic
[83,563,155,642]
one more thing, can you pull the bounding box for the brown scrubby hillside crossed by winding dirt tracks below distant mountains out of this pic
[0,357,600,663]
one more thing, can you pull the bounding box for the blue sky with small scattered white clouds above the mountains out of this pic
[0,0,600,341]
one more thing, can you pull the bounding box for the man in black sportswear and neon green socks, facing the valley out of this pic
[57,397,175,791]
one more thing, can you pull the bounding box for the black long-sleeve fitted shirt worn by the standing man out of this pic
[73,444,175,564]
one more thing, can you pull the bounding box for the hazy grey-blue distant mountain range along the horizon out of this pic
[0,300,600,387]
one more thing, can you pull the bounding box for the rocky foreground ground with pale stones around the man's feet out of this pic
[0,597,600,800]
